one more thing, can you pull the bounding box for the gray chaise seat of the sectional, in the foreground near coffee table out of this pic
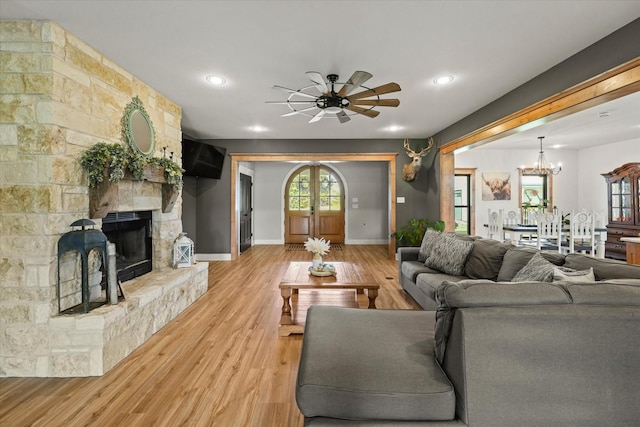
[296,305,455,421]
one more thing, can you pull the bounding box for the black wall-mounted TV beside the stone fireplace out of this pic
[182,139,227,179]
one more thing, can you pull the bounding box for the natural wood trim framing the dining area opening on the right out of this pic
[438,57,640,231]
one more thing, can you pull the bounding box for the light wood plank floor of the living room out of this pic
[0,245,419,427]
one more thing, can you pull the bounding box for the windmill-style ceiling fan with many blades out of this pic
[267,71,400,123]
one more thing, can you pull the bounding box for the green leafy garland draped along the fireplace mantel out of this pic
[80,142,182,189]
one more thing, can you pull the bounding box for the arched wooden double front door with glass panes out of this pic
[284,165,345,243]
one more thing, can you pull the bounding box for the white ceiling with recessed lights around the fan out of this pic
[0,0,640,148]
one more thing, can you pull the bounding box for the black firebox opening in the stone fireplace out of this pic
[102,211,153,282]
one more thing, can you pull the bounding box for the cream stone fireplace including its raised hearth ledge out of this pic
[0,21,207,377]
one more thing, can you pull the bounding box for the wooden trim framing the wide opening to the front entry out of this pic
[229,153,398,260]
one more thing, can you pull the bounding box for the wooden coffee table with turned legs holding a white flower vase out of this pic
[278,262,380,336]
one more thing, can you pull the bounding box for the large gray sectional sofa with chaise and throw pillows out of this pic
[296,234,640,427]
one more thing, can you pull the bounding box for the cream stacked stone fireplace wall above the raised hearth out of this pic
[0,21,201,376]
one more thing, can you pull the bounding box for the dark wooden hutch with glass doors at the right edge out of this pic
[602,163,640,260]
